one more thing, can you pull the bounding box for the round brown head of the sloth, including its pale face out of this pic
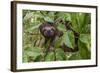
[40,22,56,38]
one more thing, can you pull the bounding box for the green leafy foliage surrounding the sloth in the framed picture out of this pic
[23,10,91,62]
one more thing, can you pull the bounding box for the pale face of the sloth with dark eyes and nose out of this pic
[43,26,56,37]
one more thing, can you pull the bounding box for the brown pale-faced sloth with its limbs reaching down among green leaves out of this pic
[39,22,63,61]
